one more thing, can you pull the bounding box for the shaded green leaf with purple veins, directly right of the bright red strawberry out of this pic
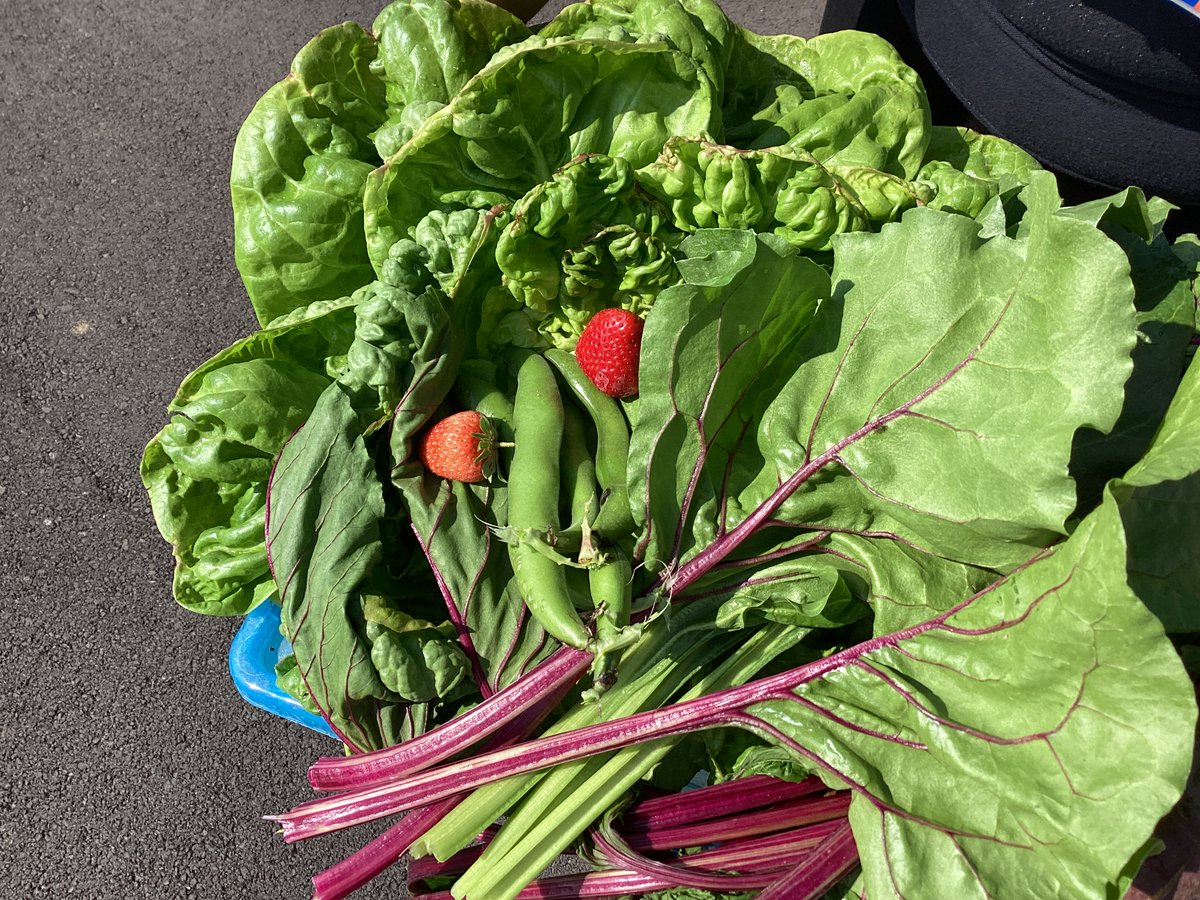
[629,230,829,570]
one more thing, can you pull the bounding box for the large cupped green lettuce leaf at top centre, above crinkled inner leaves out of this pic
[364,37,714,271]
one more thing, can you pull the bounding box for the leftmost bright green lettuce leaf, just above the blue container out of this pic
[142,298,354,616]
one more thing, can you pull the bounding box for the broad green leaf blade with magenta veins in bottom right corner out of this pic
[811,504,1195,898]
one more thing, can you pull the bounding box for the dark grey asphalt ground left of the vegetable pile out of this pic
[0,0,823,900]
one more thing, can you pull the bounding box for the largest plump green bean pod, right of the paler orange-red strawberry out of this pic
[509,353,590,649]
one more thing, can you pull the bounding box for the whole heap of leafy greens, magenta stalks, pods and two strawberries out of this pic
[142,0,1200,900]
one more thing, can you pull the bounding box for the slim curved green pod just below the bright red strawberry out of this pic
[546,349,635,541]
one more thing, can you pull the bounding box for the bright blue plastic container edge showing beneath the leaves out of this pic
[229,601,337,740]
